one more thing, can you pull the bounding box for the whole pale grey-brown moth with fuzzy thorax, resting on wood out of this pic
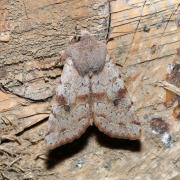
[45,32,141,148]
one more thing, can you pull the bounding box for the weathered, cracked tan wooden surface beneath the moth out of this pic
[0,0,180,180]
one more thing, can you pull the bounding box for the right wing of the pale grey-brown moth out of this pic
[91,57,141,140]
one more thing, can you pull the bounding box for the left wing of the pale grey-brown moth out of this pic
[45,58,90,148]
